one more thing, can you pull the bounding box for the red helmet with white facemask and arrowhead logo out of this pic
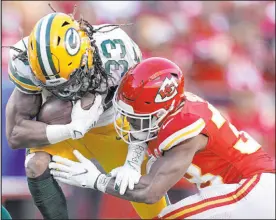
[113,57,184,144]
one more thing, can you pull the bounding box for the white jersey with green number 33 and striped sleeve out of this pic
[9,25,142,127]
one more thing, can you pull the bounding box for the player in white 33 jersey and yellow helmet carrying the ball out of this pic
[6,13,166,219]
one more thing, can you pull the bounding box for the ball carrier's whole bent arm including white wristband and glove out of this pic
[6,89,103,149]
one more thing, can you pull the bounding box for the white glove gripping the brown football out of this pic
[68,94,103,139]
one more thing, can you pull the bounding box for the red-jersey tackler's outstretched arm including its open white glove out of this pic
[49,135,208,204]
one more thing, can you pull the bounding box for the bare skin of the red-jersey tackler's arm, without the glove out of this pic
[106,134,208,204]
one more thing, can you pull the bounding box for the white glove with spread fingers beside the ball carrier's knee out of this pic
[49,150,101,189]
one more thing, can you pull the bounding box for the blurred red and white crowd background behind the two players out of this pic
[2,1,275,219]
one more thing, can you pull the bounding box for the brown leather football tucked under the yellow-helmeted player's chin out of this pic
[36,93,95,125]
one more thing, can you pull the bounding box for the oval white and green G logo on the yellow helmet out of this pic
[65,28,81,56]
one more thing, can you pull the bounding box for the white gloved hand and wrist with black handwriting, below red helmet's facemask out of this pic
[110,143,148,195]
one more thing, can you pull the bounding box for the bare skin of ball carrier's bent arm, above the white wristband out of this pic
[6,88,50,149]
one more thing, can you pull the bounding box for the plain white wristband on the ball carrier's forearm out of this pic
[46,125,71,144]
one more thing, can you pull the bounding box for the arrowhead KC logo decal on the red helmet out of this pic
[154,77,178,103]
